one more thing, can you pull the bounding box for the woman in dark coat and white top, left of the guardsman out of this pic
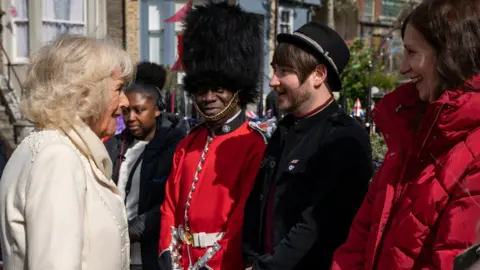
[105,63,185,270]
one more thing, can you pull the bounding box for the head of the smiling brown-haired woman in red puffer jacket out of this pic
[400,0,480,101]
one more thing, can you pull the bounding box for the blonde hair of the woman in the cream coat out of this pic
[22,35,135,128]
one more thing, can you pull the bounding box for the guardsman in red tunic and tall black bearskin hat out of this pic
[159,3,266,270]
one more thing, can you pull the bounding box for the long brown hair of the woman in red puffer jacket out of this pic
[402,0,480,96]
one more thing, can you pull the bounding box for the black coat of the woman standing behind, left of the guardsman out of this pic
[105,113,186,270]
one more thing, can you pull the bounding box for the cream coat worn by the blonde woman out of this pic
[0,121,130,270]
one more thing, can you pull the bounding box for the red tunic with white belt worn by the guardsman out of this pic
[159,121,266,270]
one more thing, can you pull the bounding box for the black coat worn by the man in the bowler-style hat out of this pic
[243,103,373,270]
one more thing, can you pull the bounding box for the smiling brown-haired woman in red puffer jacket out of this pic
[332,0,480,270]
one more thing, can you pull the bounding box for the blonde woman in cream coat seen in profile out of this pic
[0,36,134,270]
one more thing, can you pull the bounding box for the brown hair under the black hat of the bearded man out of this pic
[272,43,322,84]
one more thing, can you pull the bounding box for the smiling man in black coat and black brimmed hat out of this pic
[243,22,372,270]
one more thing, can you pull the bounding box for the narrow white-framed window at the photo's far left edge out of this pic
[9,0,29,62]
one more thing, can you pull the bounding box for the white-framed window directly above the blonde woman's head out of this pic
[42,0,86,42]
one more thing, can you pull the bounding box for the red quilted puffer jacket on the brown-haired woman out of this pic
[332,80,480,270]
